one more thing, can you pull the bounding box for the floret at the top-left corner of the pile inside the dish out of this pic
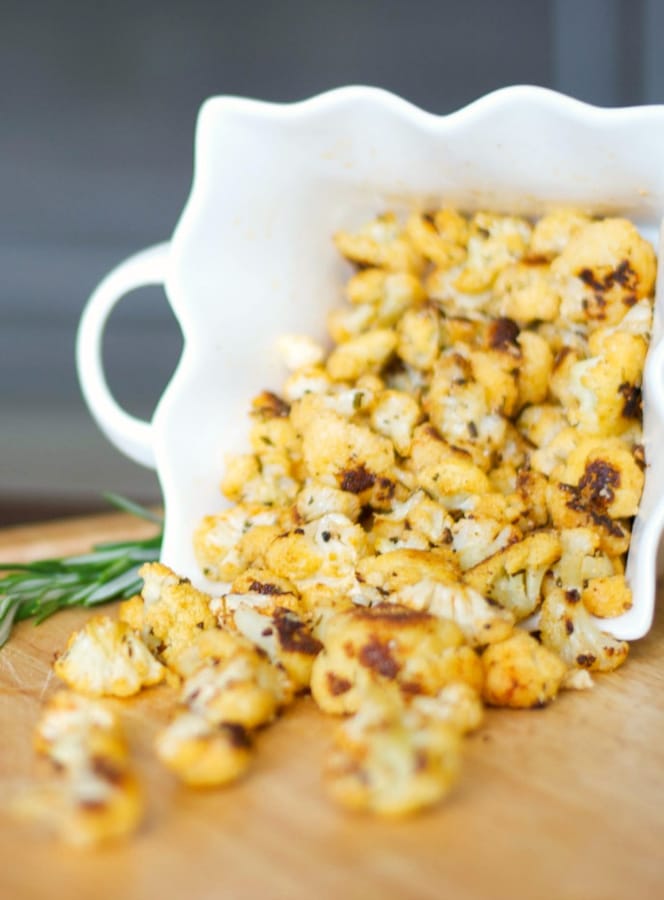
[334,213,422,272]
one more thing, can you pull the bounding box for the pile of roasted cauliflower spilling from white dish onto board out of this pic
[24,209,656,840]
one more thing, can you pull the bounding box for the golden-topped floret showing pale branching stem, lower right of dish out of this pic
[463,531,562,620]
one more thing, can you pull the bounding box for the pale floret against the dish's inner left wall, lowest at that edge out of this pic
[194,503,280,581]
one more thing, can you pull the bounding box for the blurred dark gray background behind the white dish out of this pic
[0,0,664,524]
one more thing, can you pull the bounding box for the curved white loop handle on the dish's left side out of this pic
[76,242,170,469]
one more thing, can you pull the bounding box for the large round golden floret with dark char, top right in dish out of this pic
[551,219,656,327]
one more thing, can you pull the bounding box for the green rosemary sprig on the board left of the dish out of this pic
[0,494,163,647]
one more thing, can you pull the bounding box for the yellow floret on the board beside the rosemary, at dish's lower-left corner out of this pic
[139,563,216,667]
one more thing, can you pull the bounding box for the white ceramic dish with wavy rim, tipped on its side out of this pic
[77,87,664,639]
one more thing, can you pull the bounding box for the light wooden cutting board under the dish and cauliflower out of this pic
[0,515,664,900]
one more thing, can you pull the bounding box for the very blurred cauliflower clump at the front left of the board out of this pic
[20,691,144,847]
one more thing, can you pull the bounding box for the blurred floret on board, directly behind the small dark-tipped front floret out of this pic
[180,636,293,728]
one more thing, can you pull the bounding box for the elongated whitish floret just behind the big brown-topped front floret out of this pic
[392,576,514,647]
